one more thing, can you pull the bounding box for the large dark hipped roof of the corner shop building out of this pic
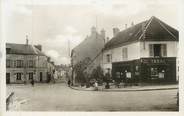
[105,16,179,49]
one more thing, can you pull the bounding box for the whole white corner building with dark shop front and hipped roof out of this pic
[102,16,179,82]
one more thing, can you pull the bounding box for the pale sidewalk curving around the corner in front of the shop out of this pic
[71,84,178,92]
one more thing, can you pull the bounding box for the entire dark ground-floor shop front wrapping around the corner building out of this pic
[112,57,176,83]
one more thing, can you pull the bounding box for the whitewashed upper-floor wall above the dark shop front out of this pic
[102,41,178,75]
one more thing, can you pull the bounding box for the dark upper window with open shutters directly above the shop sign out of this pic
[149,44,167,57]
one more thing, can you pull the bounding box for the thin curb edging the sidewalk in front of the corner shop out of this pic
[70,86,178,92]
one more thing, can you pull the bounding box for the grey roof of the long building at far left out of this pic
[6,43,45,55]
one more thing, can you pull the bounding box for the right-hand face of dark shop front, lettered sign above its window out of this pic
[140,57,176,83]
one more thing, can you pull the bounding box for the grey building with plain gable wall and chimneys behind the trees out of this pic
[71,27,106,83]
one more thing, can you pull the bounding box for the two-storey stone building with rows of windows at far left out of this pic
[6,41,53,83]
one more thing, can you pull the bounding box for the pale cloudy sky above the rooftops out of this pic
[4,0,179,64]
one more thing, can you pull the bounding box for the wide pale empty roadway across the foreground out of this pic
[7,83,177,111]
